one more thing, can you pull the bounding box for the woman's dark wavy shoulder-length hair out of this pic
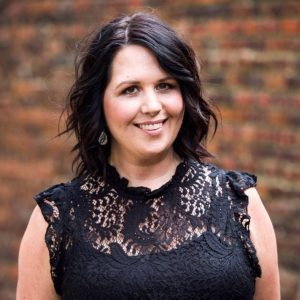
[60,13,218,176]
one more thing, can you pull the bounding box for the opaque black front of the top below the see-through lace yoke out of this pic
[62,232,255,300]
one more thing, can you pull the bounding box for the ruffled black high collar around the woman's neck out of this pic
[106,159,188,198]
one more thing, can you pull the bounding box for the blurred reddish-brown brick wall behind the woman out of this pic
[0,0,300,300]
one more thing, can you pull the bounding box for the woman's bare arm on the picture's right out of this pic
[245,188,280,300]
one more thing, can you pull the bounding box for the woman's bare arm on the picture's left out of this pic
[17,206,60,300]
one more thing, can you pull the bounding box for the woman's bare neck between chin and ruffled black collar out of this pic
[109,150,181,190]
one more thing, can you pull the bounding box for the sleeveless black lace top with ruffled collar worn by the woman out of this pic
[35,160,261,300]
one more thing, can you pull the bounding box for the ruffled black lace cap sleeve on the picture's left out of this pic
[34,184,66,294]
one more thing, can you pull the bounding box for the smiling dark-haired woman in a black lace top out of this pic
[17,13,279,300]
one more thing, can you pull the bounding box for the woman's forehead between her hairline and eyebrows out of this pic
[111,45,167,82]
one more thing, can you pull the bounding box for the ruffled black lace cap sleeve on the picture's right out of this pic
[226,171,261,277]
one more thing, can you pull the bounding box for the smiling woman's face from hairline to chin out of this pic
[103,45,184,160]
